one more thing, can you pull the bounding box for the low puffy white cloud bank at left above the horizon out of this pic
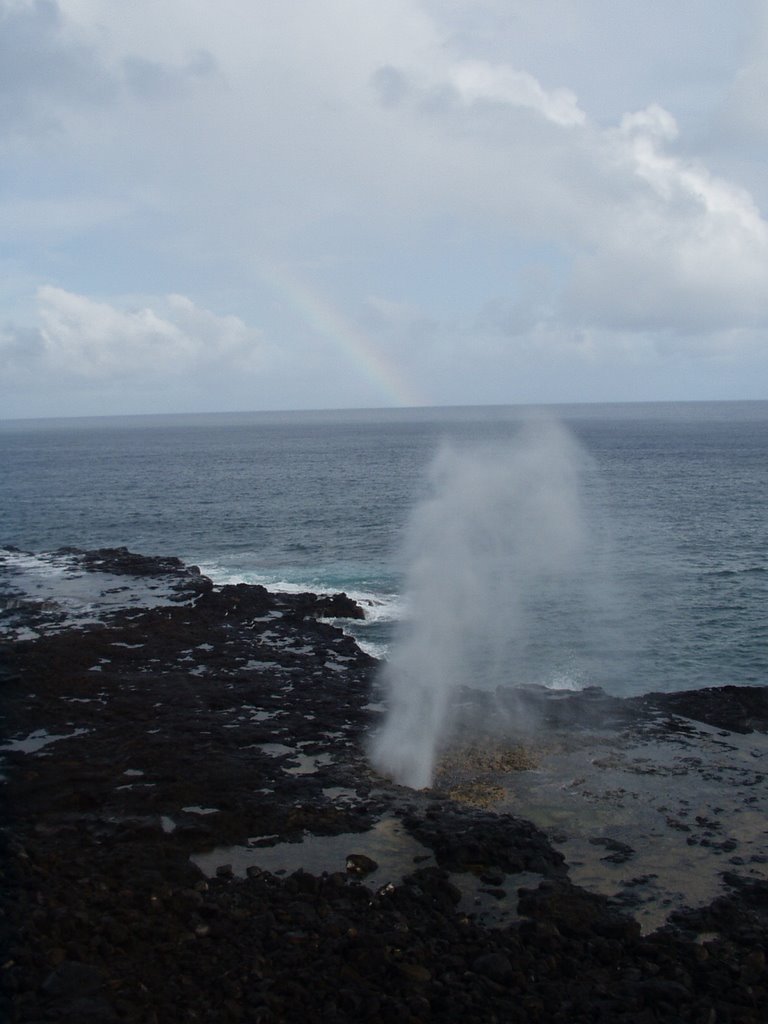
[0,285,263,383]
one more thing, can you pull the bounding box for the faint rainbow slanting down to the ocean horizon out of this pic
[260,264,427,406]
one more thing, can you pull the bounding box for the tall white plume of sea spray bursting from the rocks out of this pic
[370,423,586,788]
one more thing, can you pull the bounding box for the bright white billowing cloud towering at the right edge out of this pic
[563,106,768,333]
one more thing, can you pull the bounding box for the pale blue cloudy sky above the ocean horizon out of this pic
[0,0,768,419]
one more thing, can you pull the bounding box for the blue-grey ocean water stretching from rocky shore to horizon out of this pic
[0,402,768,693]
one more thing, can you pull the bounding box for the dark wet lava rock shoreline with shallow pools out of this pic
[0,549,768,1024]
